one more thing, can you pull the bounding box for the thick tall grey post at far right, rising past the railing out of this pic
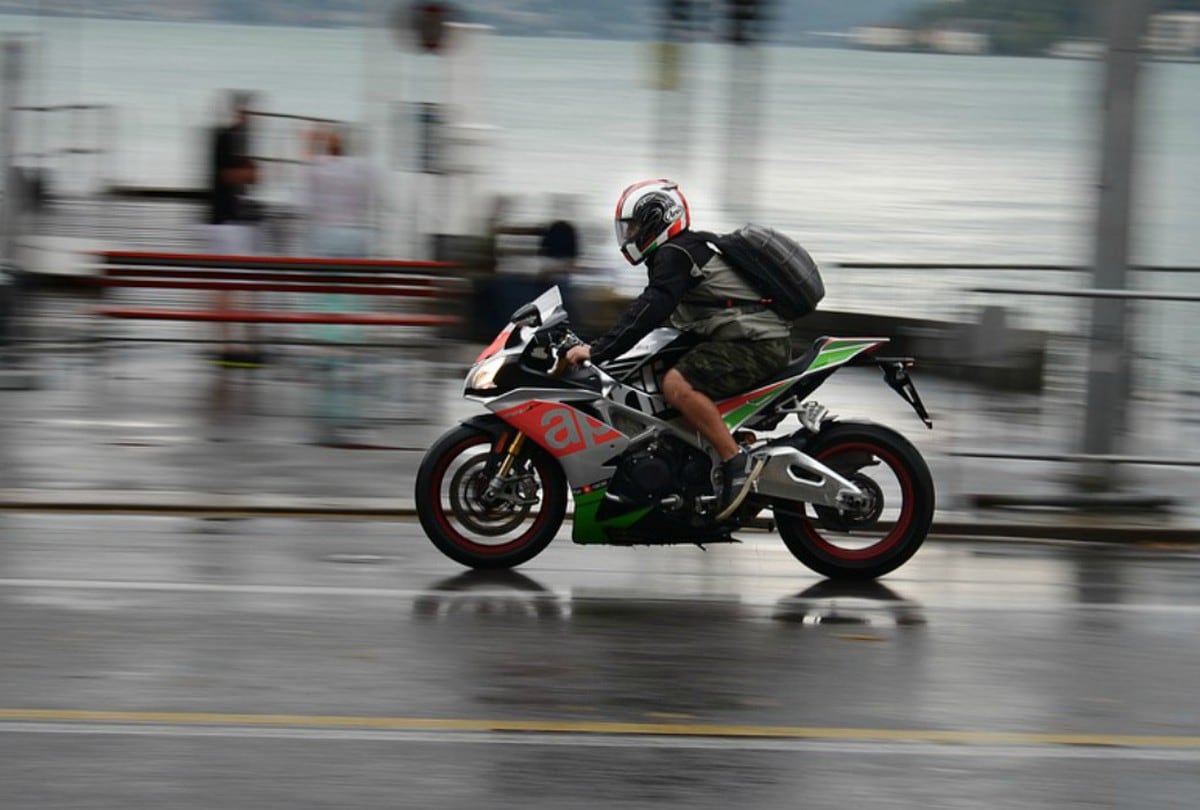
[1081,0,1153,490]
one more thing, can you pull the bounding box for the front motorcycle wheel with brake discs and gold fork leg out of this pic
[415,425,566,569]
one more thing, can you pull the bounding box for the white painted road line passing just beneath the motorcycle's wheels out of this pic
[0,577,1200,616]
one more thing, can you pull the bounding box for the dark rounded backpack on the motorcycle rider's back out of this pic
[715,223,824,320]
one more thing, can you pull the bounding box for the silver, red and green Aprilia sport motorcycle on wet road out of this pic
[415,287,934,580]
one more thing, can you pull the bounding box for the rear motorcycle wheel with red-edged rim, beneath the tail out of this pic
[775,422,934,580]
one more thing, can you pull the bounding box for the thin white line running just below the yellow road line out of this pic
[0,721,1200,762]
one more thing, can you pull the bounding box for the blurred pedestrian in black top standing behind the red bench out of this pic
[208,90,262,366]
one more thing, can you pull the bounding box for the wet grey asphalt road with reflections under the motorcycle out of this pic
[0,515,1200,810]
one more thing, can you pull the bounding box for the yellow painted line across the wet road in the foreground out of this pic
[0,709,1200,749]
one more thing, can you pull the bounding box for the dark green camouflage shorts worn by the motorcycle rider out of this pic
[676,337,792,400]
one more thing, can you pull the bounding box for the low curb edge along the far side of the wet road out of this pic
[0,490,1200,544]
